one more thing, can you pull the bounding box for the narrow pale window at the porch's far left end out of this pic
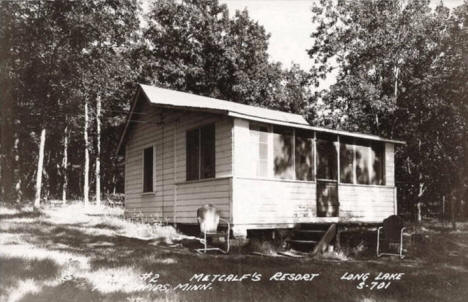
[250,124,269,177]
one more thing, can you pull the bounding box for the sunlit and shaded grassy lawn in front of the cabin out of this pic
[0,205,468,302]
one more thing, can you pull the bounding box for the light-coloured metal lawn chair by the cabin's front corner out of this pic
[196,204,231,254]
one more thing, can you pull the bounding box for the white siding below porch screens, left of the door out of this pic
[233,178,316,224]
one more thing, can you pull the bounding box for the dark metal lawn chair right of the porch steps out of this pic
[377,215,406,259]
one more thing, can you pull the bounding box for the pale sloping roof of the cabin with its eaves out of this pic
[117,84,405,153]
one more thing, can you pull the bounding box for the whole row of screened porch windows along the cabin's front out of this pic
[248,123,385,185]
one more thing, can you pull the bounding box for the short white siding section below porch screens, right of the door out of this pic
[338,184,395,221]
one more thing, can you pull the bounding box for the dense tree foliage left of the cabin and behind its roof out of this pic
[0,0,309,201]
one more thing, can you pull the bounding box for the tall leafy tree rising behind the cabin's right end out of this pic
[309,0,460,218]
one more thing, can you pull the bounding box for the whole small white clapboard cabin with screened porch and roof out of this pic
[118,85,404,236]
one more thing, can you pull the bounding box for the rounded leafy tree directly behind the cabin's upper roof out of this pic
[135,0,310,109]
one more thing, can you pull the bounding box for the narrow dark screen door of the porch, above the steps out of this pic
[316,135,340,217]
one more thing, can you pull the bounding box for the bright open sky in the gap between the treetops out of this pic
[219,0,463,70]
